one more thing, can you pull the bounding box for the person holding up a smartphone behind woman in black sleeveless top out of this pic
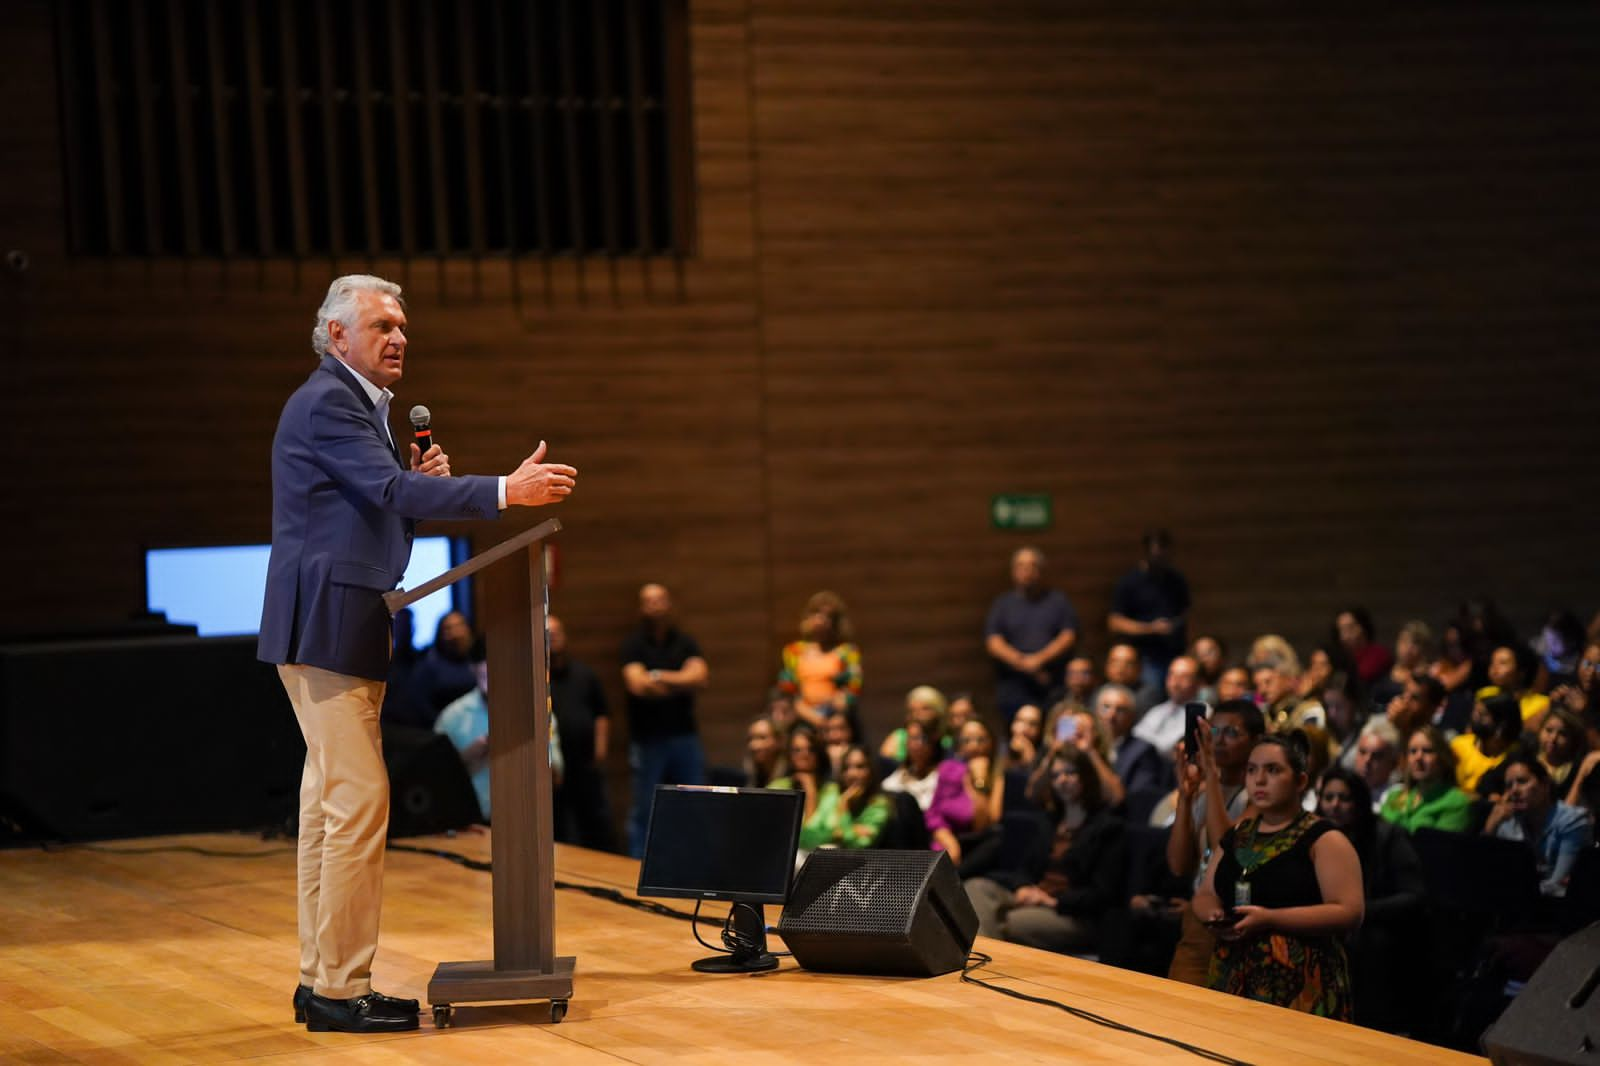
[1166,699,1266,984]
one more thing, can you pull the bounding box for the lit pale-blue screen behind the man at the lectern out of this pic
[144,536,466,633]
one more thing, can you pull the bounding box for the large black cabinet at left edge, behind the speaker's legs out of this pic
[0,635,306,844]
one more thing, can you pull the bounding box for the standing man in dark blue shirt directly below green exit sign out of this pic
[984,547,1078,723]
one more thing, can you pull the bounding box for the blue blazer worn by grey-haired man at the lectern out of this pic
[256,355,499,680]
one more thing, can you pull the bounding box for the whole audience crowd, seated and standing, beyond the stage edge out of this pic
[386,531,1600,1042]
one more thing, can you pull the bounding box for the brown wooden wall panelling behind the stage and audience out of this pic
[0,0,1600,819]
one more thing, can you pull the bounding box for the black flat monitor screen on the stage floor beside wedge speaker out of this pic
[638,784,805,904]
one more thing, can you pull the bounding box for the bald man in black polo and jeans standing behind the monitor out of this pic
[622,584,710,858]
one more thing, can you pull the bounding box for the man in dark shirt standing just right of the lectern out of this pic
[549,615,616,852]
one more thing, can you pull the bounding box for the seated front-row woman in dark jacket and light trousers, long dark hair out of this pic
[963,747,1126,952]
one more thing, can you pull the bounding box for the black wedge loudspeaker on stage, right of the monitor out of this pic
[778,848,978,976]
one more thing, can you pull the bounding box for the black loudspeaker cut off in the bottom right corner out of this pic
[1483,922,1600,1066]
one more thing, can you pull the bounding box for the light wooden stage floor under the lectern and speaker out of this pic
[0,836,1485,1066]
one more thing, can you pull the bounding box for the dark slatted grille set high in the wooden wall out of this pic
[58,0,693,260]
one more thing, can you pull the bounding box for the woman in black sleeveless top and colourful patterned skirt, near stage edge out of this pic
[1194,730,1365,1021]
